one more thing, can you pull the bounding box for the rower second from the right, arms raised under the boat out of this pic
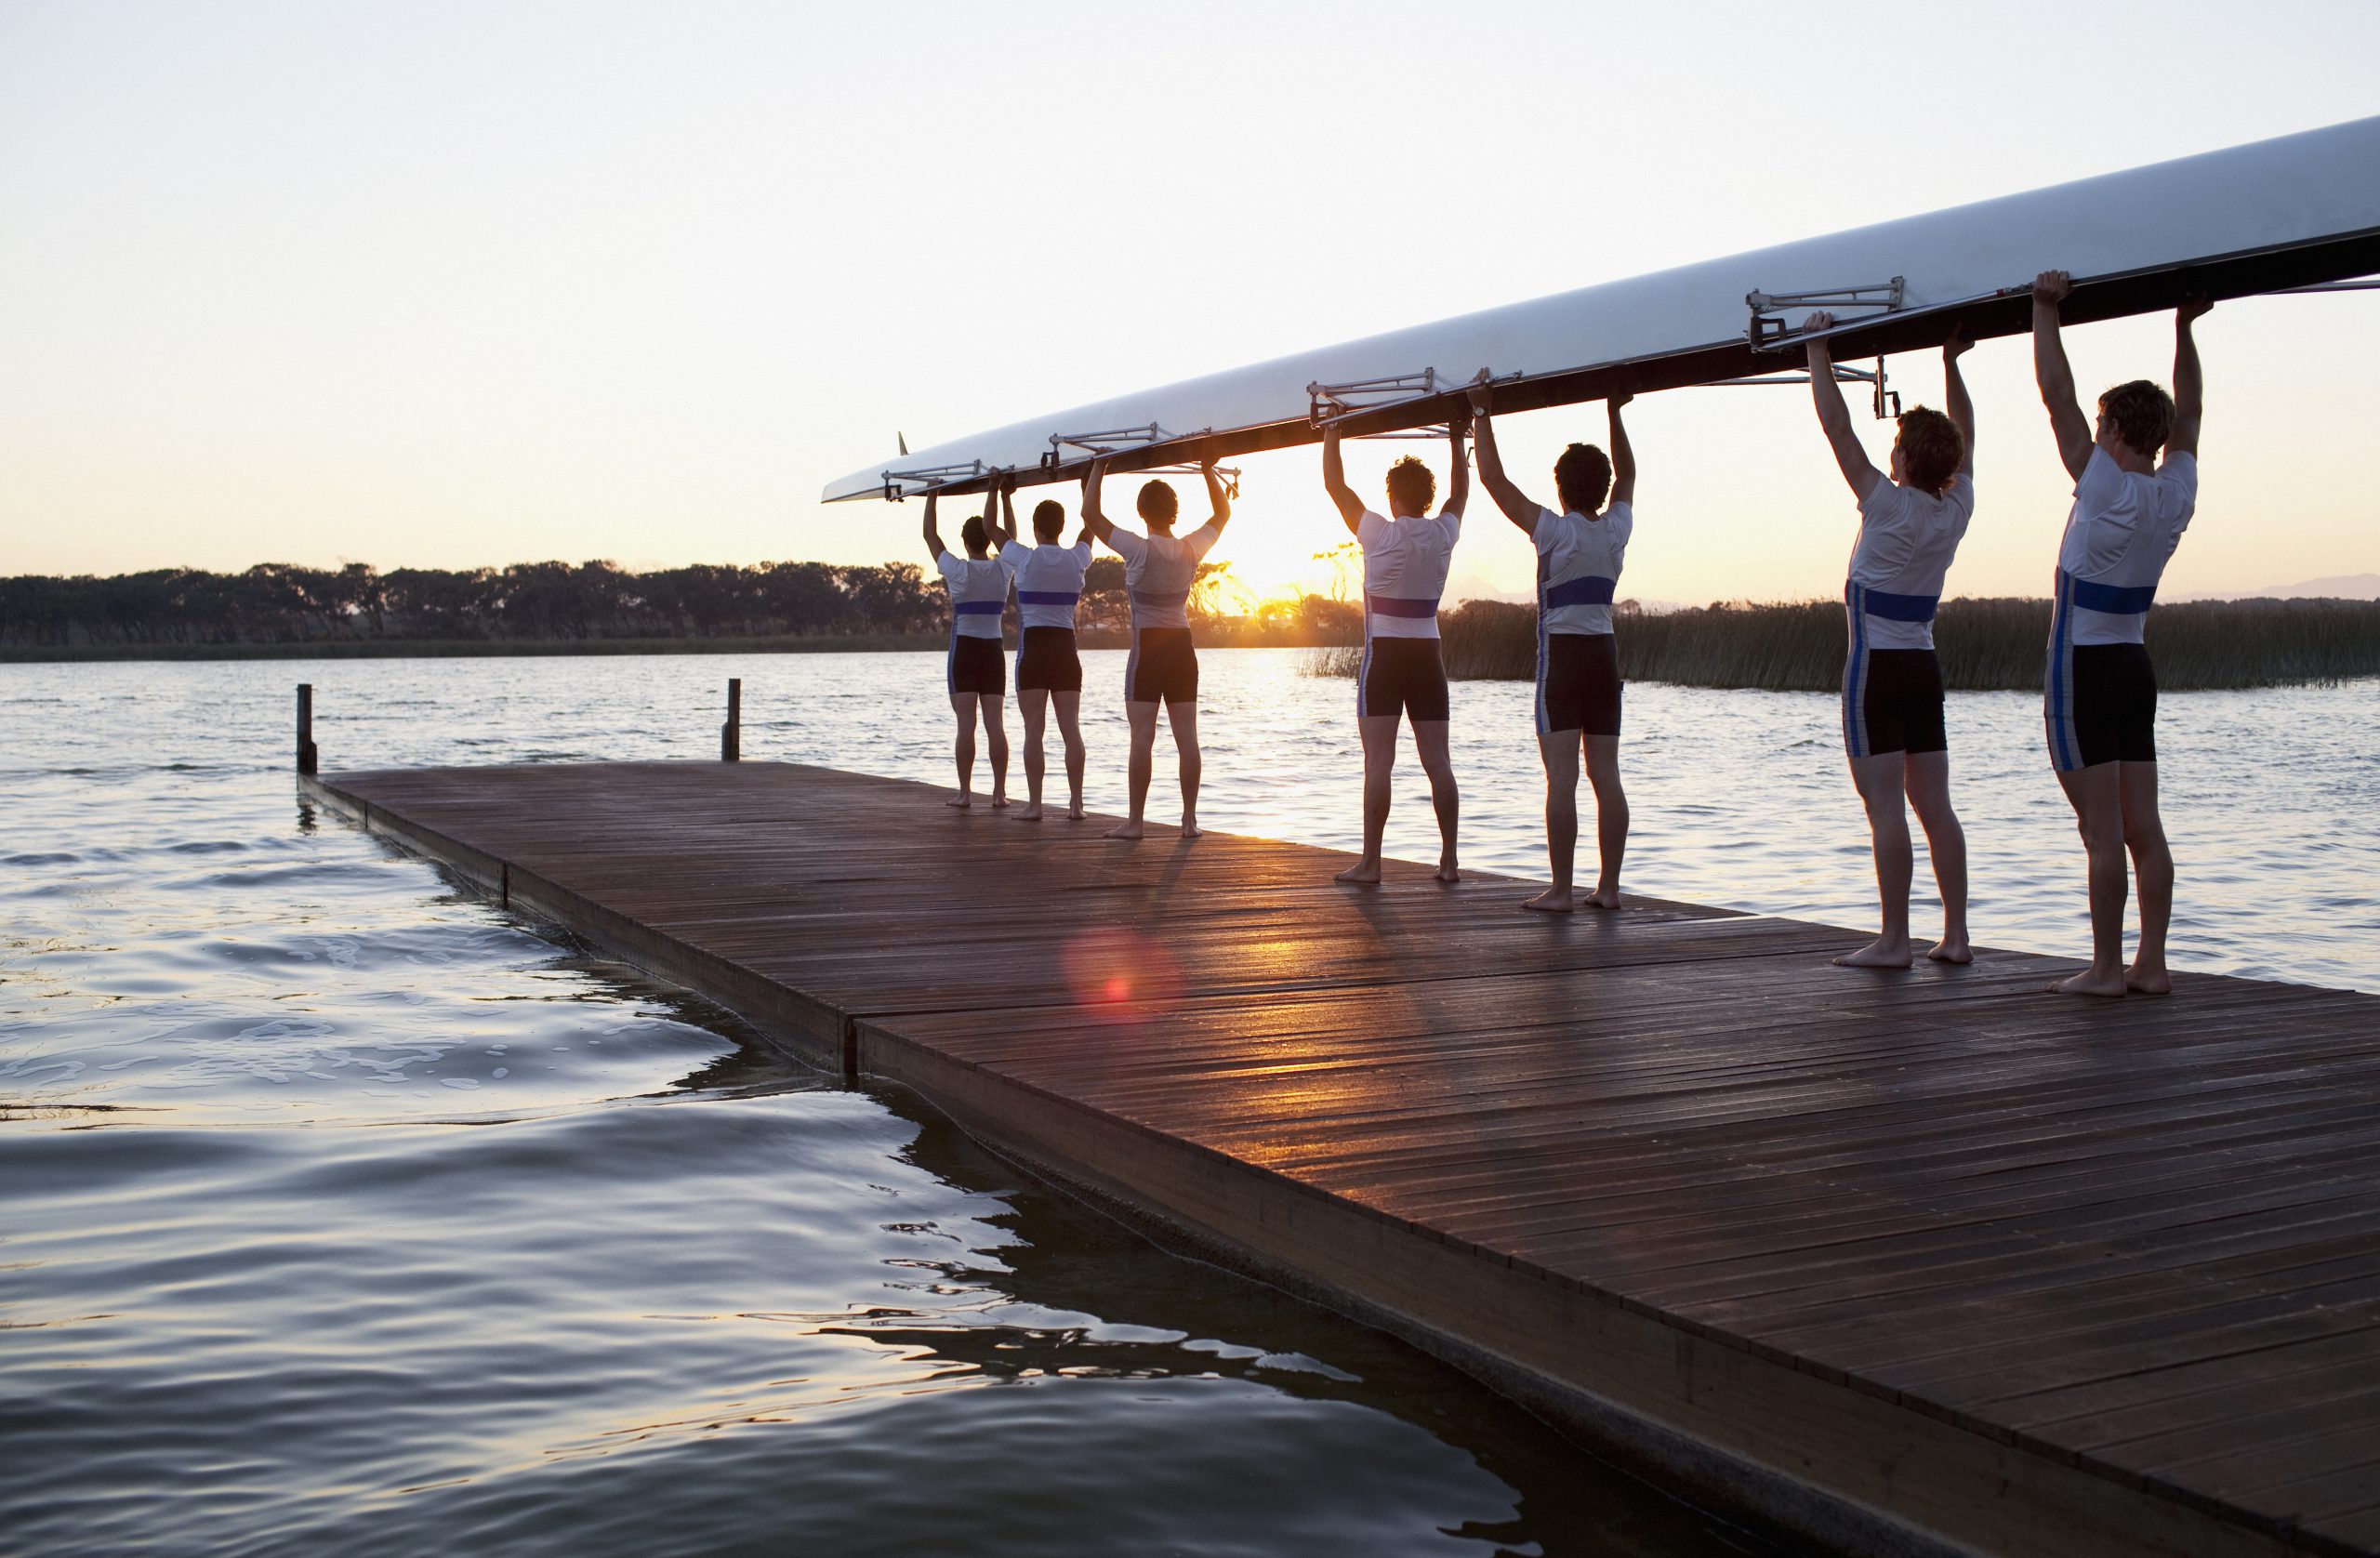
[1802,311,1976,968]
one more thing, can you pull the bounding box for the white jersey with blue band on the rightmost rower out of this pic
[2054,444,2199,644]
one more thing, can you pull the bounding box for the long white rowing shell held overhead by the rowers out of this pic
[824,116,2380,502]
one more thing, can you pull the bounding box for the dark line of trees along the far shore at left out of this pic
[0,557,1361,647]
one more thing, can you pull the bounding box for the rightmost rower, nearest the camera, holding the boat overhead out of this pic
[2032,271,2214,997]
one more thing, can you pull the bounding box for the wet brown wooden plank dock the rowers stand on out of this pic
[300,763,2380,1558]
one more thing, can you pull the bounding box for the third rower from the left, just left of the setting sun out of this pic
[1083,456,1231,839]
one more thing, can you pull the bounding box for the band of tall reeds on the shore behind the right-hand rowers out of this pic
[1312,600,2380,693]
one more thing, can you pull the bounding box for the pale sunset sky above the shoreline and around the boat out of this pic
[0,0,2380,601]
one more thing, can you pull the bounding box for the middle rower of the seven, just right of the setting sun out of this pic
[1323,418,1471,882]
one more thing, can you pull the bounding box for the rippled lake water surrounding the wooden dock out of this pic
[0,652,2380,1555]
